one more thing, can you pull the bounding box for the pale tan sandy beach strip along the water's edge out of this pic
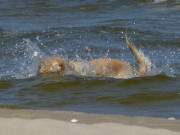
[0,109,180,135]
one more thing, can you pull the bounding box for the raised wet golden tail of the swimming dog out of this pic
[125,35,152,76]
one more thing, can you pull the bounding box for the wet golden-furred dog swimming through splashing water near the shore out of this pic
[39,36,151,78]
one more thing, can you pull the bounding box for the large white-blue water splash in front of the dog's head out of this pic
[0,39,43,79]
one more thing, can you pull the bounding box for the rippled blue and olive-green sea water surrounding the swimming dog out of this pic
[0,0,180,118]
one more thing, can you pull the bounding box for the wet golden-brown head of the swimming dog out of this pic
[39,57,65,74]
